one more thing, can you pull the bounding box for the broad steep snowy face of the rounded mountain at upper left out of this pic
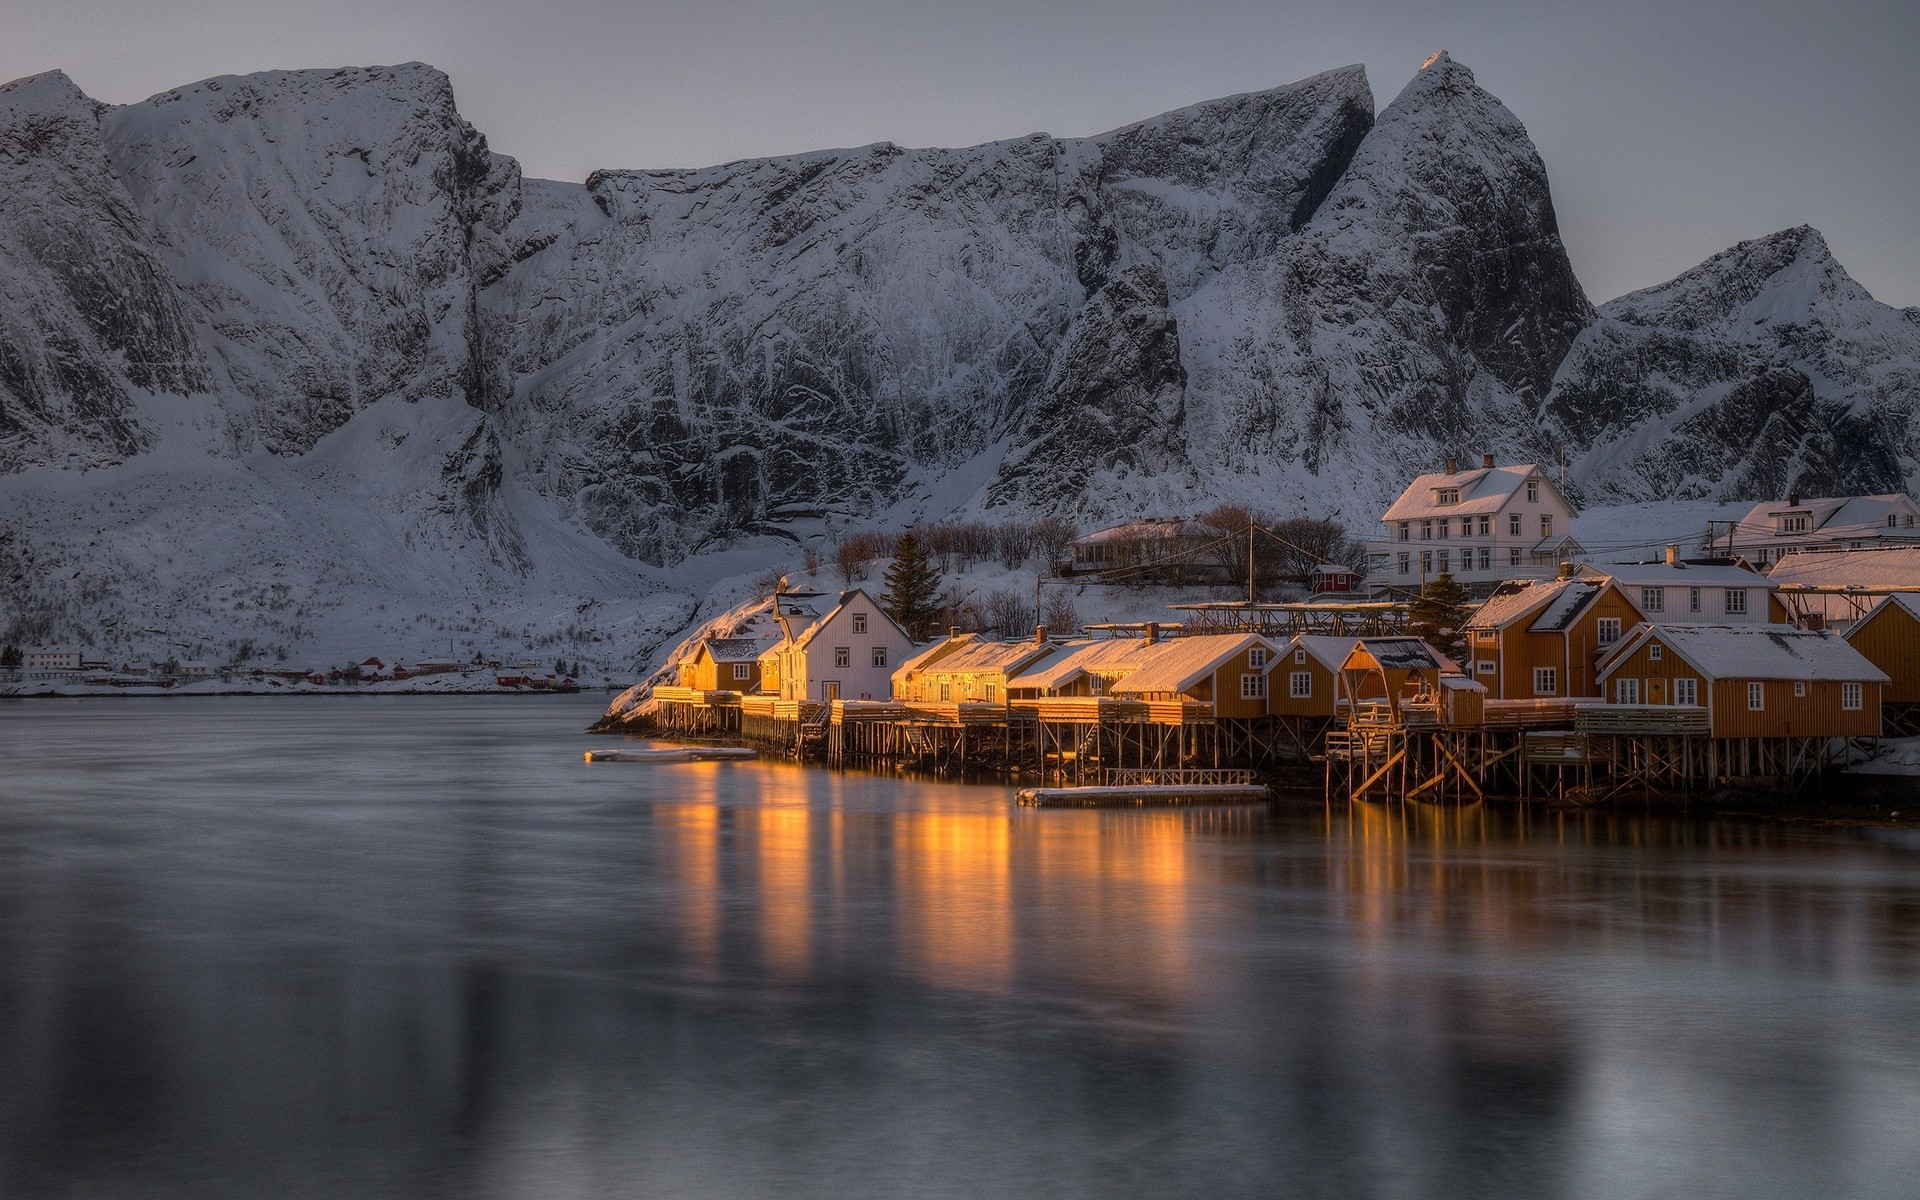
[106,63,518,453]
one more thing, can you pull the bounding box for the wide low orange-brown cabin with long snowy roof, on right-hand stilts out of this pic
[1599,624,1887,737]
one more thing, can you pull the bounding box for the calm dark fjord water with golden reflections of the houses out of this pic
[0,697,1920,1198]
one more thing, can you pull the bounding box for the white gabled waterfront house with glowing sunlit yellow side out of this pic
[760,588,916,701]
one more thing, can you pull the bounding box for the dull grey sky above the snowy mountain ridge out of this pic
[11,0,1920,305]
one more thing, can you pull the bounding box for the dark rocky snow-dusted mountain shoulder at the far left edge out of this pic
[0,71,207,472]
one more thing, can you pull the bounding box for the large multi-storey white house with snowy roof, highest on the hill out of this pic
[1367,455,1582,593]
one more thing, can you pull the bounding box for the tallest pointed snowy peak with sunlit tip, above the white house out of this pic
[1175,54,1592,524]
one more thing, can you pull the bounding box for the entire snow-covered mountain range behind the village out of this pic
[0,54,1920,662]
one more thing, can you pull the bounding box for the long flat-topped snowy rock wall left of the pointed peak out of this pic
[486,67,1373,563]
